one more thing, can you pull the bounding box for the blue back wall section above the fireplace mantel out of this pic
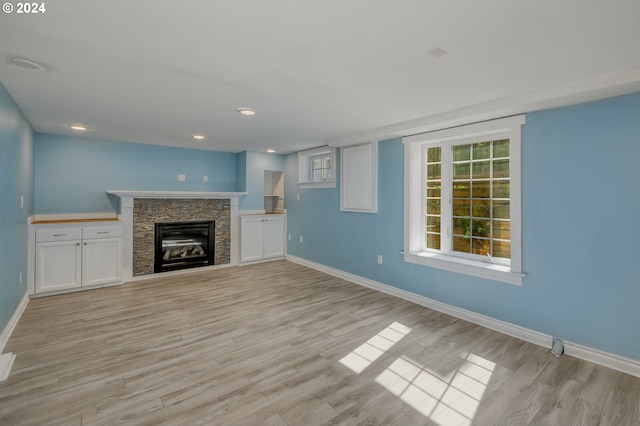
[35,133,237,214]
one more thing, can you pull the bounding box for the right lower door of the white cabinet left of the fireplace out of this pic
[82,238,122,286]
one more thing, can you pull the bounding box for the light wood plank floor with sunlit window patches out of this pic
[0,261,640,426]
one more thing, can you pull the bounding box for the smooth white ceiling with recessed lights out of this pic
[0,0,640,152]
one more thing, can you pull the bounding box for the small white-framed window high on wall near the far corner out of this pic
[298,146,336,188]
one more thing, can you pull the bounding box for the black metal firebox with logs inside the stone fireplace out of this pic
[153,220,215,273]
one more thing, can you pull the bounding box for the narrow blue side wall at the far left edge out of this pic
[0,83,33,332]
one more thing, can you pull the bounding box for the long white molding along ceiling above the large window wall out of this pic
[328,66,640,147]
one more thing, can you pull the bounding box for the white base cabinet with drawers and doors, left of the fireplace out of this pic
[35,225,122,294]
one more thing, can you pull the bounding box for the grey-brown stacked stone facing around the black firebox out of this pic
[133,198,231,276]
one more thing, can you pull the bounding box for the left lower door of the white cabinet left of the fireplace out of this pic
[35,240,82,293]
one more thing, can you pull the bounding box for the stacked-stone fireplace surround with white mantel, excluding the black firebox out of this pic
[107,190,245,281]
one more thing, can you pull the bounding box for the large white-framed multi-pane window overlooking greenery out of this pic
[404,116,524,284]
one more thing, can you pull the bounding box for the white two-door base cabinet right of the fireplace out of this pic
[240,214,285,263]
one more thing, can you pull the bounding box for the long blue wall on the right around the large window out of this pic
[285,94,640,360]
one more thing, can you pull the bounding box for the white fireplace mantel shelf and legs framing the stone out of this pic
[106,189,247,281]
